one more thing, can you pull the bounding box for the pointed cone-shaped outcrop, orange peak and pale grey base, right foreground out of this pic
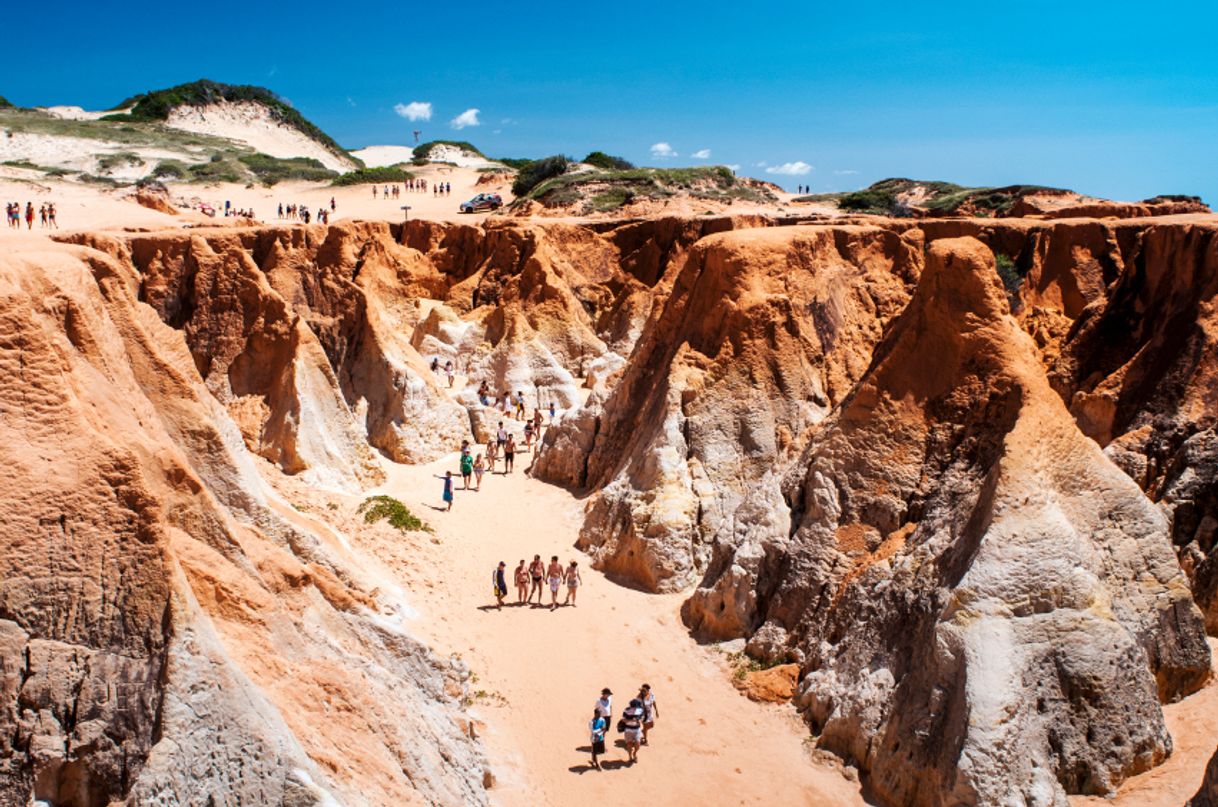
[758,239,1209,805]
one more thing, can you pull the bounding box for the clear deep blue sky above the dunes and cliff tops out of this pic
[0,0,1218,203]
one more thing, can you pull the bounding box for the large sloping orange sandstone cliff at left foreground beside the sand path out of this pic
[0,245,485,806]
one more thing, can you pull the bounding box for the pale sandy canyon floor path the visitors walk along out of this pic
[372,454,864,807]
